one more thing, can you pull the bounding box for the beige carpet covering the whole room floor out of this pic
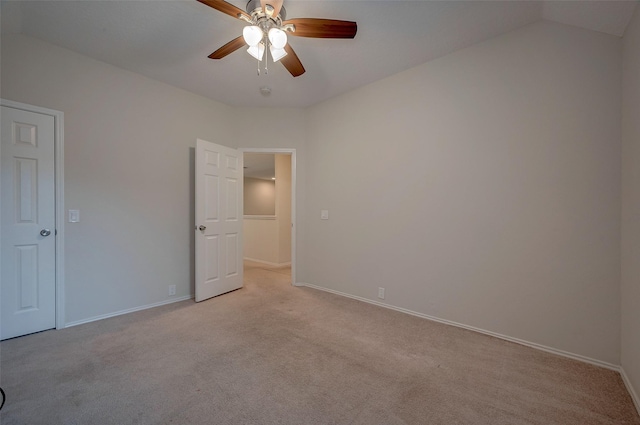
[0,264,640,425]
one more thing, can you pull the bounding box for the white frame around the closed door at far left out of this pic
[0,99,66,329]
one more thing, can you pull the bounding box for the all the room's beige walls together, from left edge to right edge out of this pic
[0,15,639,374]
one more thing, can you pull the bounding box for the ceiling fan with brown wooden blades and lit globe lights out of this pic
[198,0,358,77]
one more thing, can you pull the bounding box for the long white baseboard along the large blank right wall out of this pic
[304,283,620,372]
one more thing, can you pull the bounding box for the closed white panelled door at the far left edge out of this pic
[0,106,56,339]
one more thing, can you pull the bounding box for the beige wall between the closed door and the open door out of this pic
[0,34,234,322]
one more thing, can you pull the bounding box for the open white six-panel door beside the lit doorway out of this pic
[195,139,243,301]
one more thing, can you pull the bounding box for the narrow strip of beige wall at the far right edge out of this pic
[622,6,640,410]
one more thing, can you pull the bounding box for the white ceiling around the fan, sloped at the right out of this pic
[2,0,638,107]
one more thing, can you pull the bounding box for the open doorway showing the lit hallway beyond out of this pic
[240,148,296,285]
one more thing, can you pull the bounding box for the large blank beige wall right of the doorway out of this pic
[300,22,621,364]
